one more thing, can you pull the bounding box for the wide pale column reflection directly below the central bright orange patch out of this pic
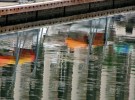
[71,48,88,100]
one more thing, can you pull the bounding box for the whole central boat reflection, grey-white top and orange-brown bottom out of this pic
[65,18,111,49]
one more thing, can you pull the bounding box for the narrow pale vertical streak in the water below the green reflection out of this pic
[100,69,108,100]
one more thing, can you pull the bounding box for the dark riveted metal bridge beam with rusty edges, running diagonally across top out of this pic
[0,0,135,33]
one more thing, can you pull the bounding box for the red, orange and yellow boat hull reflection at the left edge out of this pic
[0,49,35,67]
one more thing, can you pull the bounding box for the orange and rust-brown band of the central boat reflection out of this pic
[65,33,104,49]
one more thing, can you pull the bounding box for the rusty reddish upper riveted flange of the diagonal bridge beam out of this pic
[0,0,104,16]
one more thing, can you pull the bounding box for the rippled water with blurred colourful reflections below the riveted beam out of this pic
[0,13,135,100]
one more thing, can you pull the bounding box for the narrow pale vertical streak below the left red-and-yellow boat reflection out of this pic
[14,65,22,100]
